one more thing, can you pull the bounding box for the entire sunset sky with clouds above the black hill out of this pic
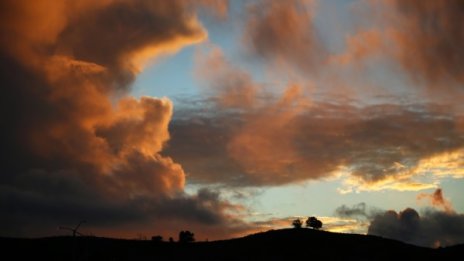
[0,0,464,247]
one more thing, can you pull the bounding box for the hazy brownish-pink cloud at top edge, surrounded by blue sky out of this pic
[244,0,325,74]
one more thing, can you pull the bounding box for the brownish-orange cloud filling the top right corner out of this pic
[344,0,464,88]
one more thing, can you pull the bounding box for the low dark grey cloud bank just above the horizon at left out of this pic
[0,171,241,238]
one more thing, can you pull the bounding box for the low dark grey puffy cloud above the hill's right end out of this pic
[368,208,464,247]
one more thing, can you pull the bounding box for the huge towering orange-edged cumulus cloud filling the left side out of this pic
[0,0,243,236]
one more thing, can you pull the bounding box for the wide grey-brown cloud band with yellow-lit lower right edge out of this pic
[166,100,463,191]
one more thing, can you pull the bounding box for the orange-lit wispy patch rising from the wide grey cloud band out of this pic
[227,85,316,183]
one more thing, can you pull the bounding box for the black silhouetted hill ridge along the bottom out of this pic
[0,228,464,261]
